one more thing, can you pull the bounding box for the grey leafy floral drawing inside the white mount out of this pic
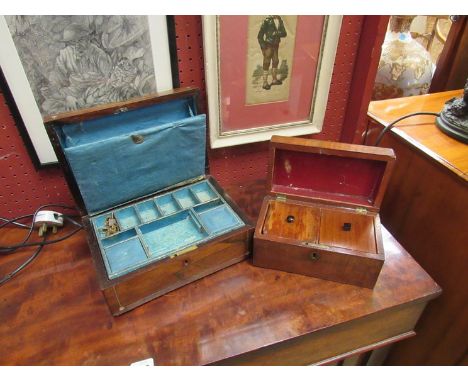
[5,16,156,116]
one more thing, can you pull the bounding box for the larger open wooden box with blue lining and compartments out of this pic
[46,88,254,315]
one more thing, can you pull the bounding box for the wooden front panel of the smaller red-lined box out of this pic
[253,238,383,288]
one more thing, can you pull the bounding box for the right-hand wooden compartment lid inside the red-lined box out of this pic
[319,208,377,253]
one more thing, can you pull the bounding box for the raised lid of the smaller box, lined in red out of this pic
[269,136,395,211]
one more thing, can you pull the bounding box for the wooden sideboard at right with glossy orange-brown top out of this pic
[367,90,468,365]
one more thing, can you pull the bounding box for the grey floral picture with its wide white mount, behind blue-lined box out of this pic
[0,15,173,167]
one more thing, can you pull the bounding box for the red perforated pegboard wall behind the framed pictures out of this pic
[0,16,363,217]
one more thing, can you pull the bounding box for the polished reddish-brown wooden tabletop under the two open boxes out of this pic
[0,182,440,365]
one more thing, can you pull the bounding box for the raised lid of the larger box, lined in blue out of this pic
[45,88,206,215]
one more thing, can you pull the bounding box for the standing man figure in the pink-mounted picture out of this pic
[257,16,287,90]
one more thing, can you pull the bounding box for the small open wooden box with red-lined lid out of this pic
[253,136,395,288]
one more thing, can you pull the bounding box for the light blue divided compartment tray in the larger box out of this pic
[91,180,245,279]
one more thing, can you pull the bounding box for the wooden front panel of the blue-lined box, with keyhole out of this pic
[104,229,252,314]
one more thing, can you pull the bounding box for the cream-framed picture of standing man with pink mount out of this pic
[203,15,341,148]
